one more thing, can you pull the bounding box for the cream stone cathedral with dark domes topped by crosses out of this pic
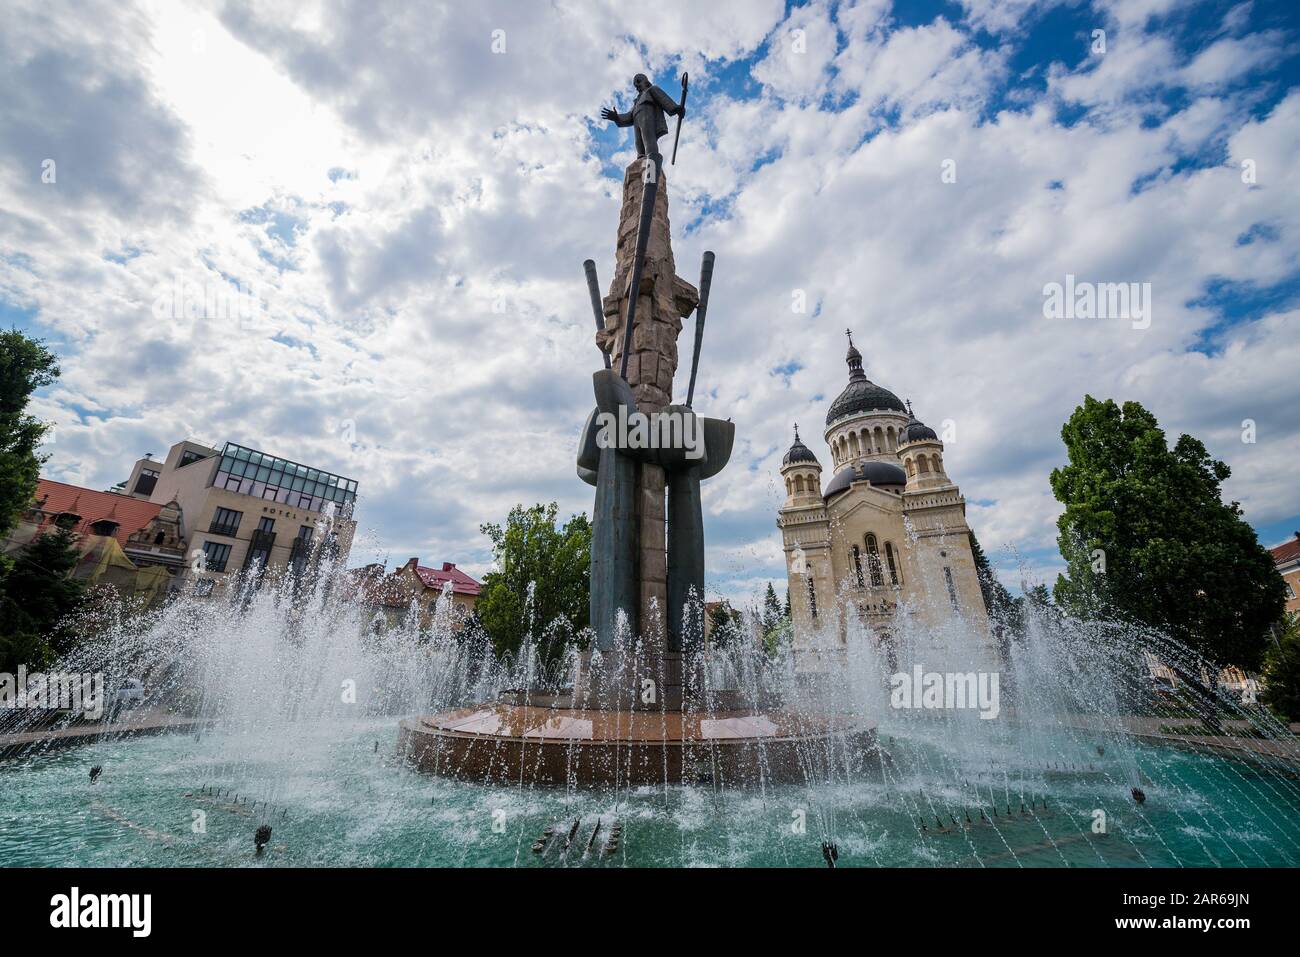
[776,333,988,659]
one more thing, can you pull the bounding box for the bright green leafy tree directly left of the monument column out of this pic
[475,502,592,668]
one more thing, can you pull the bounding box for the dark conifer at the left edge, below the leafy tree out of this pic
[0,528,86,672]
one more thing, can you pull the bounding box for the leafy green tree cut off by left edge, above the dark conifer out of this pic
[0,329,59,536]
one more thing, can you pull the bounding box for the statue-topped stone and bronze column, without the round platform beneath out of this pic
[579,74,733,710]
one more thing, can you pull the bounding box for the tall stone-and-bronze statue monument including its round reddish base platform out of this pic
[399,74,875,790]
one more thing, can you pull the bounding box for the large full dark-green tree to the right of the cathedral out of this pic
[1052,395,1284,668]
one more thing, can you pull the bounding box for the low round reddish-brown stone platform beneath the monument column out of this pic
[398,703,876,787]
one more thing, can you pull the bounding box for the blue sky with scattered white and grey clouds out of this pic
[0,0,1300,605]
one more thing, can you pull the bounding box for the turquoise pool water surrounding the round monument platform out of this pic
[0,719,1300,867]
